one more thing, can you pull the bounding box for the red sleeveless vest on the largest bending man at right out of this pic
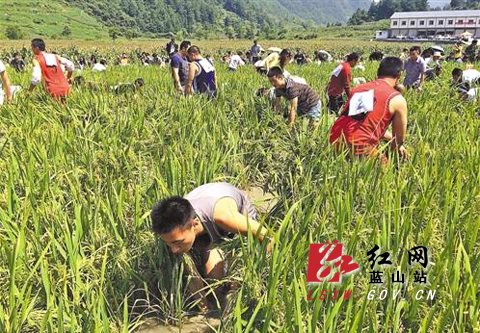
[330,79,400,155]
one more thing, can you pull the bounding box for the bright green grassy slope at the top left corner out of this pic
[0,0,108,39]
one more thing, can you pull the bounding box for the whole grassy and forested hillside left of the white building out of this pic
[0,0,376,40]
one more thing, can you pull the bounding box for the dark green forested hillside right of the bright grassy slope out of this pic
[66,0,275,37]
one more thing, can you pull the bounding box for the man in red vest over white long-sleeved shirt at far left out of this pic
[29,38,75,103]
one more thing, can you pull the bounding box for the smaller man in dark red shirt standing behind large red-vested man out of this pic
[327,53,360,114]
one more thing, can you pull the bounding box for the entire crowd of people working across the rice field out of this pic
[0,38,480,309]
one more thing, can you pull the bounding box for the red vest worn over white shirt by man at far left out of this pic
[35,53,70,98]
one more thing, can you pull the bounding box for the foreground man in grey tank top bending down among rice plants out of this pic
[151,183,267,311]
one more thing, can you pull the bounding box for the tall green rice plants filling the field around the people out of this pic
[0,50,480,332]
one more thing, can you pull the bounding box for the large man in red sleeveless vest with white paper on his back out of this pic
[330,57,407,161]
